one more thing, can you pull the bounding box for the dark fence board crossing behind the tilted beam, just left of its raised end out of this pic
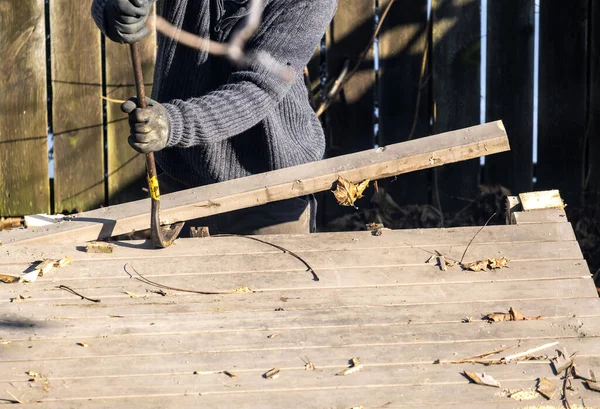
[432,0,481,211]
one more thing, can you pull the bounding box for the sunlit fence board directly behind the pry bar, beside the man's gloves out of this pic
[106,8,156,205]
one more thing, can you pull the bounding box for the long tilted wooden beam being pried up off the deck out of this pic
[0,122,508,245]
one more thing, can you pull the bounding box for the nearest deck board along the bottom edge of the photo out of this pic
[8,382,600,409]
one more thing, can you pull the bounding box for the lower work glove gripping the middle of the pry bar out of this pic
[121,97,170,153]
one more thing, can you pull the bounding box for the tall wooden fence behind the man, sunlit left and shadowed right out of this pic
[0,0,600,223]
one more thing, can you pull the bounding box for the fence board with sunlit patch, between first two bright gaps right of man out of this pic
[377,0,431,204]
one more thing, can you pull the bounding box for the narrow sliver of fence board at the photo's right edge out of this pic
[586,0,600,204]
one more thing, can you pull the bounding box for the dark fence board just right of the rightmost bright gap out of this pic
[536,0,588,204]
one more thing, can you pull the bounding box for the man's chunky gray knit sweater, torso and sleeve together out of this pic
[92,0,337,187]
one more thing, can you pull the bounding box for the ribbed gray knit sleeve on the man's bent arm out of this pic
[163,0,337,147]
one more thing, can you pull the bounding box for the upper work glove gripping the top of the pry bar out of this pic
[104,0,152,44]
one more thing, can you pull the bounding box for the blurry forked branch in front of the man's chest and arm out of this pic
[156,0,294,82]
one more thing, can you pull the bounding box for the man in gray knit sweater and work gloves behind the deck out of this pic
[92,0,337,234]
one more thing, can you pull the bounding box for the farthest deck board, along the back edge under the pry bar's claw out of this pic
[0,220,575,265]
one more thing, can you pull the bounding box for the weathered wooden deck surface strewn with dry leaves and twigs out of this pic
[0,207,600,409]
